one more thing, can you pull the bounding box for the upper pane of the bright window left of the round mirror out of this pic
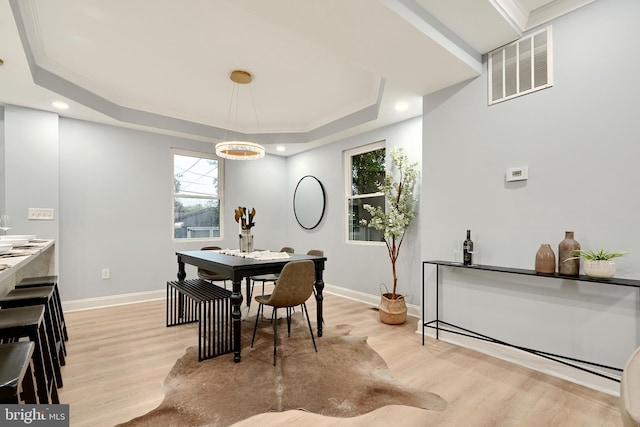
[173,154,218,197]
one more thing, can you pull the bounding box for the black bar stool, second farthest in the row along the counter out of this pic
[0,286,66,388]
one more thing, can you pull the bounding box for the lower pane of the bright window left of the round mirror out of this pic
[174,197,220,239]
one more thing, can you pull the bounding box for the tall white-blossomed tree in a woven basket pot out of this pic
[360,148,418,324]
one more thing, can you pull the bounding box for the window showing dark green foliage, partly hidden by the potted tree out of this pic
[344,141,385,242]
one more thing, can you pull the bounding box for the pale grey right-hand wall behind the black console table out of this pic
[421,0,640,394]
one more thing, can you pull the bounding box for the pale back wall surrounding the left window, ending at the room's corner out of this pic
[59,119,285,300]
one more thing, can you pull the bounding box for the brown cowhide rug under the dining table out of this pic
[122,311,447,427]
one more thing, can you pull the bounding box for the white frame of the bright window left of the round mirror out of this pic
[169,147,224,243]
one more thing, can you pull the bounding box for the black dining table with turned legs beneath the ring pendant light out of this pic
[176,250,327,363]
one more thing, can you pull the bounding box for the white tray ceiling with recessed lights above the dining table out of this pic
[0,0,591,154]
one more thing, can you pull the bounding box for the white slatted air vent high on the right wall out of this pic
[488,27,553,105]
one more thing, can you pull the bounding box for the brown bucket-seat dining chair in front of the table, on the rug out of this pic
[251,260,318,366]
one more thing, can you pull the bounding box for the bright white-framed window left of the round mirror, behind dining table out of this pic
[172,150,223,239]
